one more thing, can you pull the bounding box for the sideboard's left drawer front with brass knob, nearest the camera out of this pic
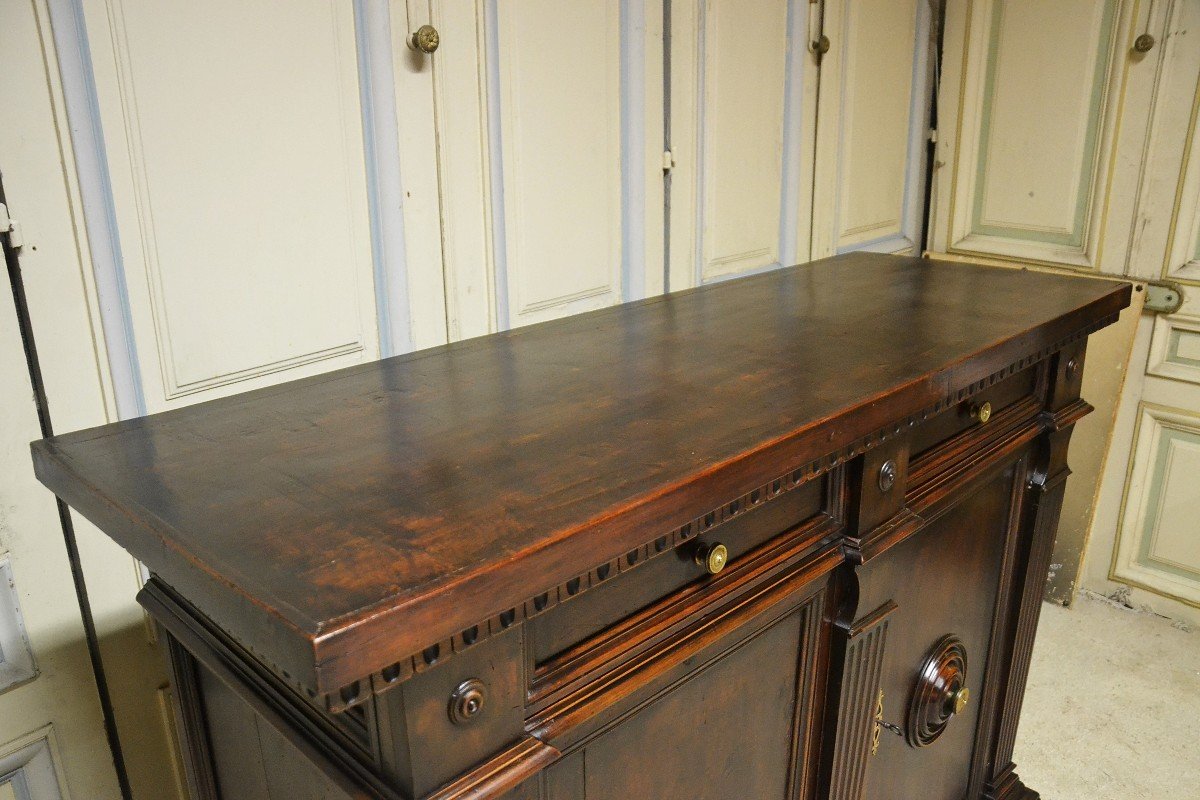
[527,476,829,675]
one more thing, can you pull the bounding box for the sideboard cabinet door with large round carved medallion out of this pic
[854,461,1025,800]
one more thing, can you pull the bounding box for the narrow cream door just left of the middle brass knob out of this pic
[667,0,817,290]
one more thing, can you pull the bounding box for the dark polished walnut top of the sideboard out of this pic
[32,254,1129,692]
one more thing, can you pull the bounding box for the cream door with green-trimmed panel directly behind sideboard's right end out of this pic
[929,0,1176,603]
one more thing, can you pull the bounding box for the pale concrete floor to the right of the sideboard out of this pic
[1013,595,1200,800]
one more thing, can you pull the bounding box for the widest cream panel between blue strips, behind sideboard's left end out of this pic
[85,0,378,410]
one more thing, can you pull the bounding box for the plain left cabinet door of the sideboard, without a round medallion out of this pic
[542,595,823,800]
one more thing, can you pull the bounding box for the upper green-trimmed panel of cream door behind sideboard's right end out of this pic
[947,0,1130,269]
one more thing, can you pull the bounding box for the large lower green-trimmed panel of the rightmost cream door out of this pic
[1112,403,1200,604]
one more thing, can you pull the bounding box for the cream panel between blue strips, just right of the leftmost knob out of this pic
[498,0,622,325]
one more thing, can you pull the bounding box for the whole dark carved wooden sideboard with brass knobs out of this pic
[34,254,1130,800]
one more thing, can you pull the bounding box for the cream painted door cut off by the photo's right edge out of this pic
[1085,0,1200,624]
